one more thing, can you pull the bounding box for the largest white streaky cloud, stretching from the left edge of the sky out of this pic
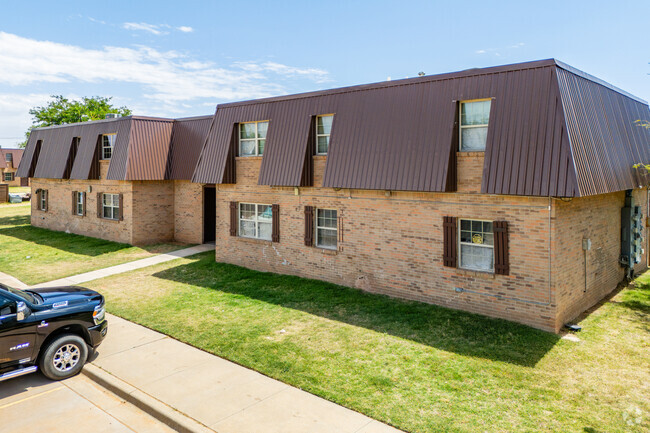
[0,32,328,104]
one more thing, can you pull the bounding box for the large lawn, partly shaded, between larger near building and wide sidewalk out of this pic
[83,253,650,433]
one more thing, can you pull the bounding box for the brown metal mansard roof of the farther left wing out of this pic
[17,116,212,180]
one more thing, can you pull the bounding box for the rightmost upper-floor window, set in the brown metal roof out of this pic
[459,99,492,152]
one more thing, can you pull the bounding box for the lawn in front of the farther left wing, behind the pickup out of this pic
[0,203,187,285]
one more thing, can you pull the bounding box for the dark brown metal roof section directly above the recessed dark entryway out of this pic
[165,115,213,180]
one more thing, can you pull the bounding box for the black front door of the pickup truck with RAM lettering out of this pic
[0,295,36,368]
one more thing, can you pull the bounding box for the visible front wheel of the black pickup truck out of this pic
[40,335,88,380]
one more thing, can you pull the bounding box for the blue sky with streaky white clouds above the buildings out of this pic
[0,0,650,147]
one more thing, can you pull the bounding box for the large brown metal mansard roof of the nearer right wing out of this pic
[193,59,650,197]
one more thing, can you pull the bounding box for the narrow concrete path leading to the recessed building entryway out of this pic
[32,244,214,287]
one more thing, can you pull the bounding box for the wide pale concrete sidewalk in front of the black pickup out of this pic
[92,315,399,433]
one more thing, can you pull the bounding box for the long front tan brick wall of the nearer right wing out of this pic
[216,158,555,331]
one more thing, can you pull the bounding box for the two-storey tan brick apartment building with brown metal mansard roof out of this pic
[20,60,650,332]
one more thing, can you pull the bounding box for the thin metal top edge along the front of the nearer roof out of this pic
[217,58,556,109]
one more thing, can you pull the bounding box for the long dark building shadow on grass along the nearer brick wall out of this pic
[154,252,559,367]
